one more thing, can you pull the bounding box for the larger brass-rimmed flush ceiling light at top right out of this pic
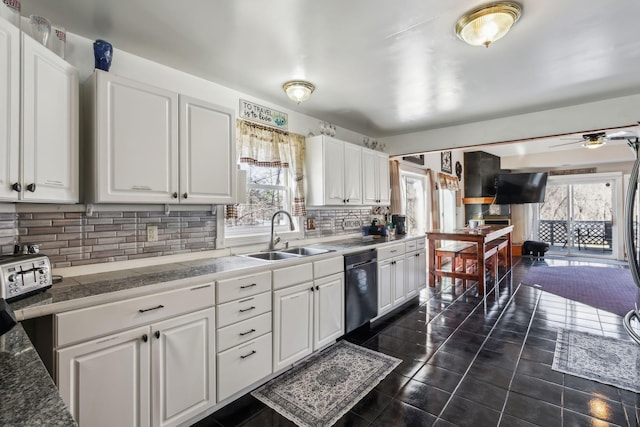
[456,1,522,47]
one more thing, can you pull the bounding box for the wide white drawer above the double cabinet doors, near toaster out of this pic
[55,284,214,347]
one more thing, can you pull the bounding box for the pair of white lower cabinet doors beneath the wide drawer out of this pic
[56,308,216,427]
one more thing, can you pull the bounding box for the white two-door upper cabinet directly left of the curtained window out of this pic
[85,70,236,204]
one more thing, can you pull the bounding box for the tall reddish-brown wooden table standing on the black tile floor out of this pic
[427,225,513,293]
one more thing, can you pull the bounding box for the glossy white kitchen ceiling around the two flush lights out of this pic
[17,0,640,143]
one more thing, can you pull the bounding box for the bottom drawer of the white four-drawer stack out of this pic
[217,333,272,401]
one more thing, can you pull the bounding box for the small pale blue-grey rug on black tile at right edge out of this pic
[552,329,640,393]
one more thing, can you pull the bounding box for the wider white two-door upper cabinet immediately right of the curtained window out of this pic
[305,135,362,206]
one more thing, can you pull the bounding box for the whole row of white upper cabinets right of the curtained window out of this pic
[306,135,391,206]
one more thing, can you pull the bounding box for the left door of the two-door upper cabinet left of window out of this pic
[94,71,179,203]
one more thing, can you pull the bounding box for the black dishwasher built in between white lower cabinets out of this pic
[344,249,378,333]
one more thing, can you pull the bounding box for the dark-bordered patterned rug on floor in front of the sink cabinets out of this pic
[251,341,401,427]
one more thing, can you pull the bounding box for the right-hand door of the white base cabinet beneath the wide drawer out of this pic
[151,308,216,427]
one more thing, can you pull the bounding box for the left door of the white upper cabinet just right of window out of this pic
[322,137,347,205]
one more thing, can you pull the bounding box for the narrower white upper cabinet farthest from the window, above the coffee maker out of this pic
[362,148,391,205]
